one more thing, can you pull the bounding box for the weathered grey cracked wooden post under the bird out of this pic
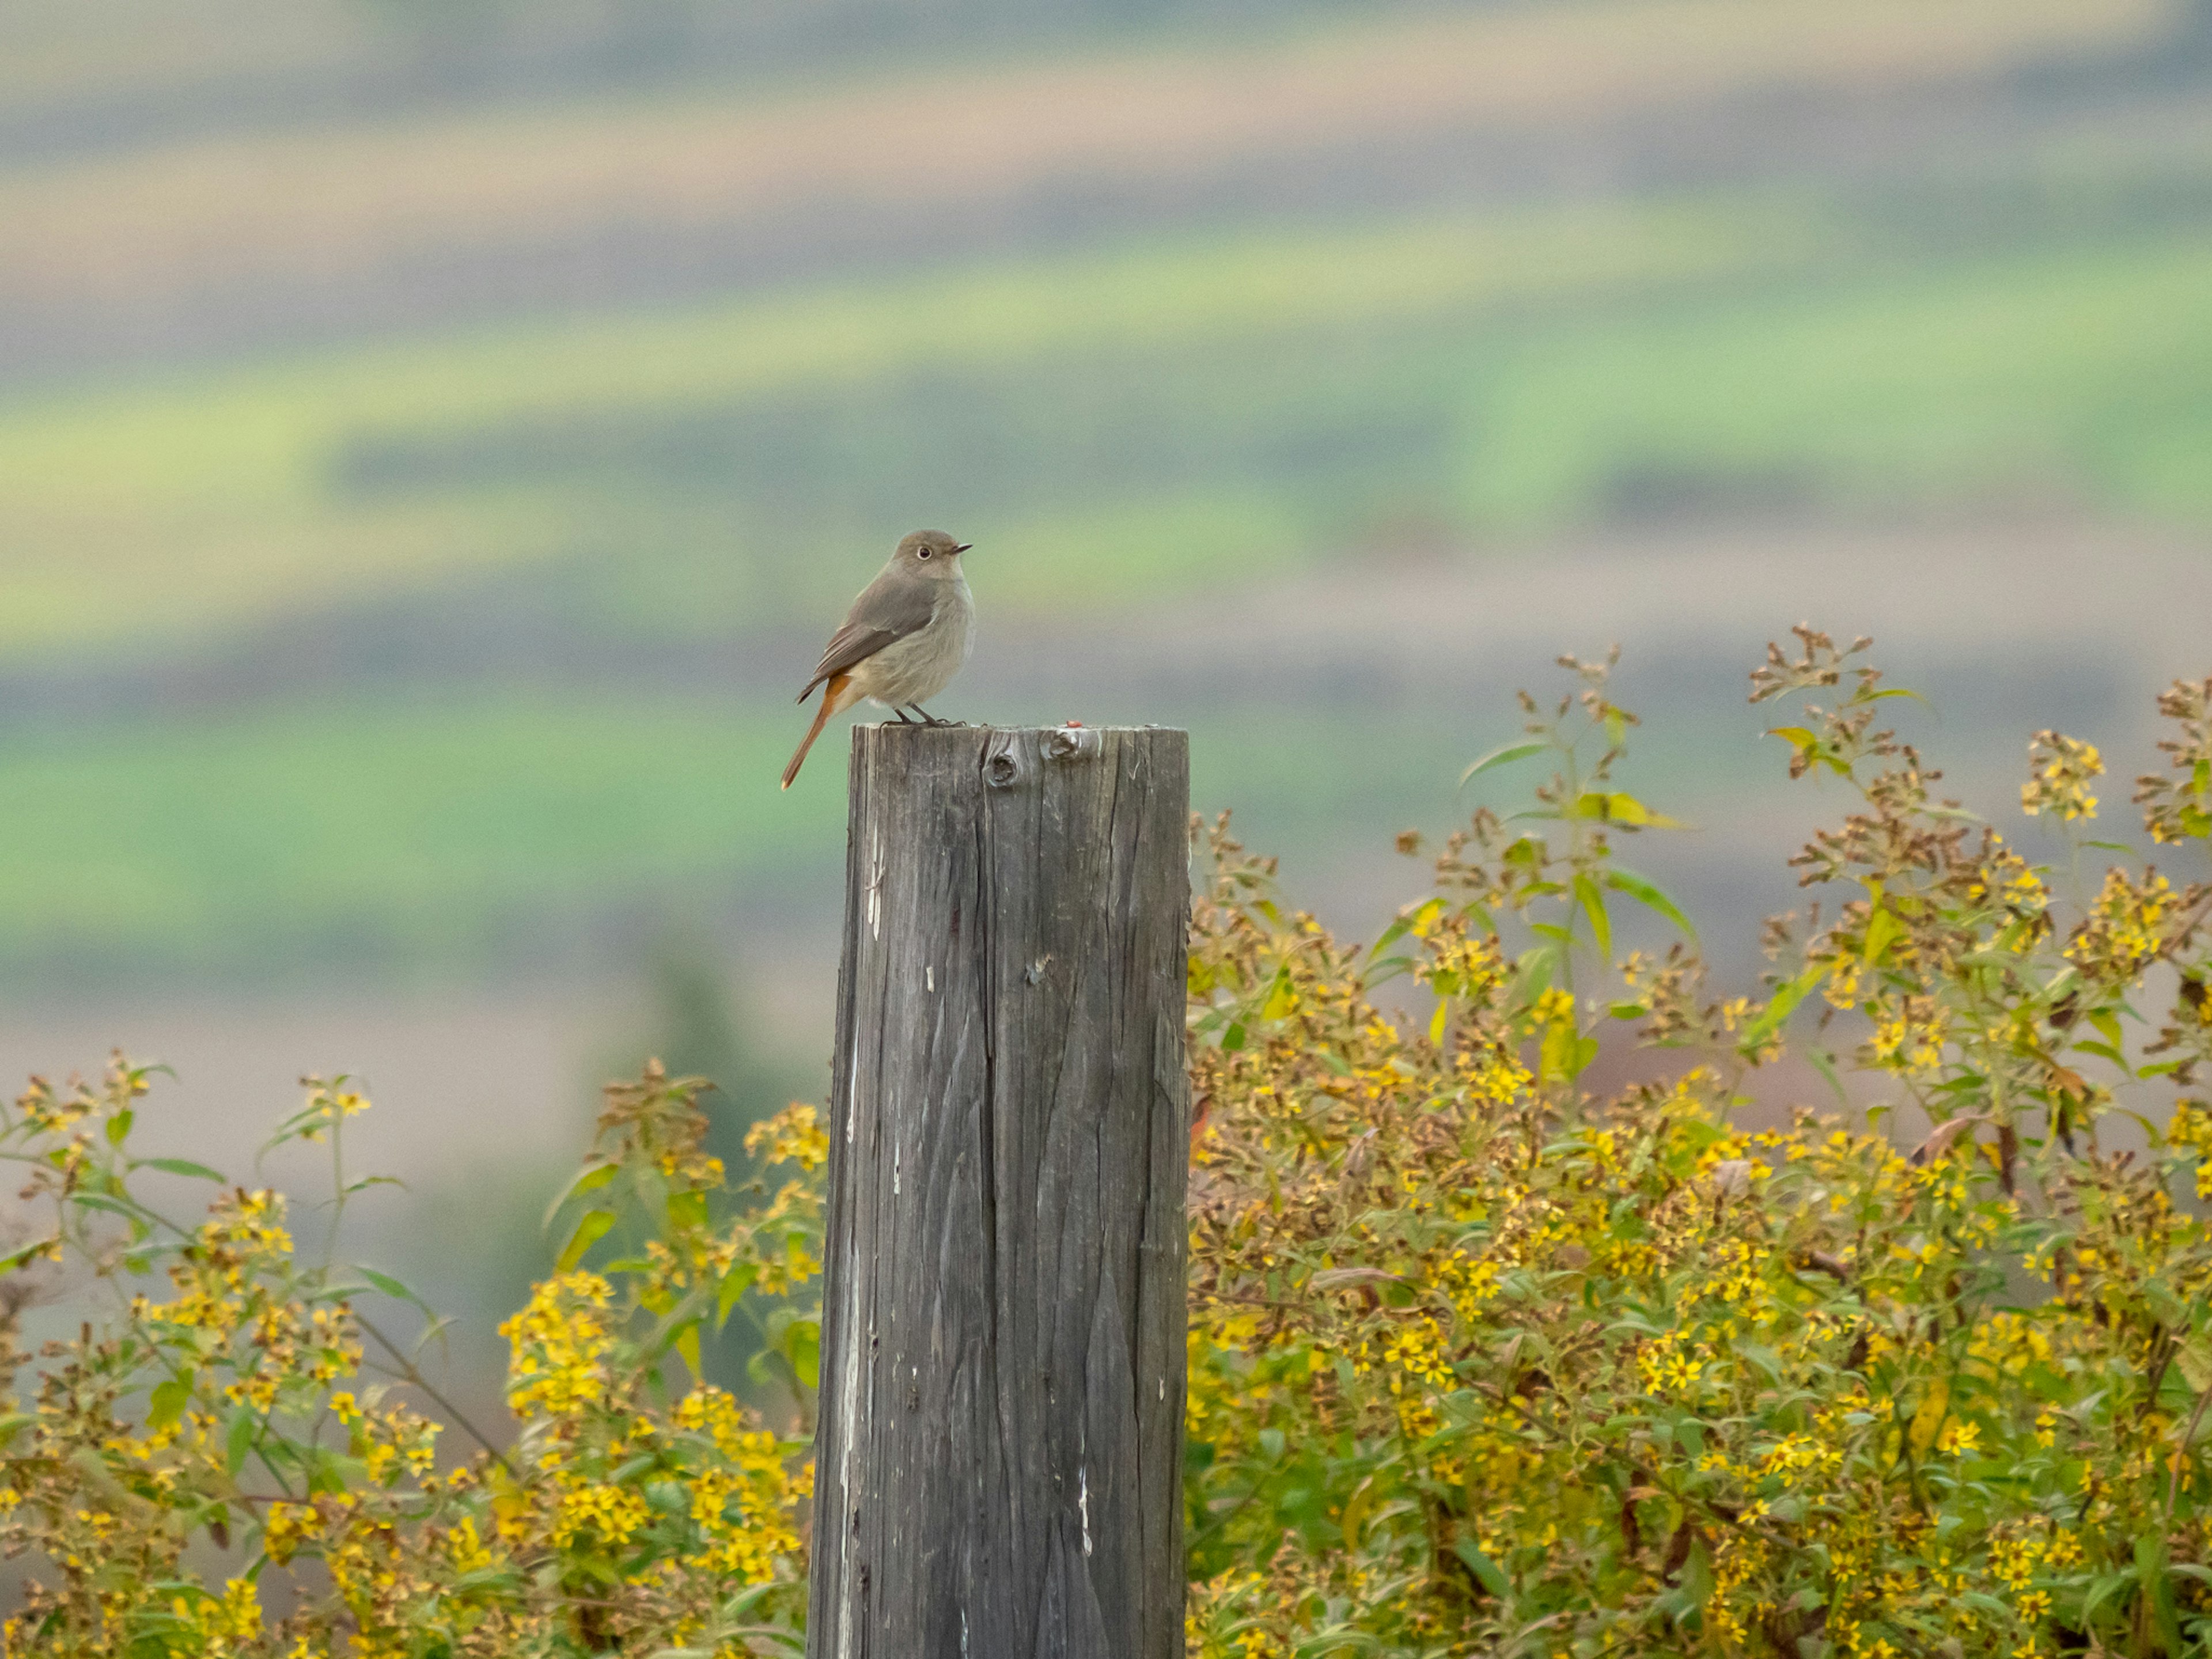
[808,726,1190,1659]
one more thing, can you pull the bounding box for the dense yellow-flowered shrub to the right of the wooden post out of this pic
[1185,632,2212,1659]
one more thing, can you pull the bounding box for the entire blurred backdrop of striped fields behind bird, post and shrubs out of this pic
[0,0,2212,1415]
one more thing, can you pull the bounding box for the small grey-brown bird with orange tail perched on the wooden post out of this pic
[783,531,975,790]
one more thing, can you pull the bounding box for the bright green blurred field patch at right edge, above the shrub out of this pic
[1469,234,2212,524]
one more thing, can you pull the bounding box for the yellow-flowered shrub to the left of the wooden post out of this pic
[0,1062,827,1659]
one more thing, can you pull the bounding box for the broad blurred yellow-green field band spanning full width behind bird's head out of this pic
[0,199,2212,657]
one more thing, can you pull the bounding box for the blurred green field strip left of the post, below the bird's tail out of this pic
[0,692,838,982]
